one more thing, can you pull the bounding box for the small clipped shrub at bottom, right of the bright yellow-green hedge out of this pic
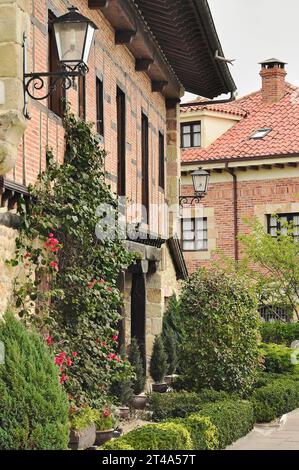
[173,414,219,450]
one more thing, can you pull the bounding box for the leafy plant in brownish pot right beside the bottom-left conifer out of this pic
[69,406,96,450]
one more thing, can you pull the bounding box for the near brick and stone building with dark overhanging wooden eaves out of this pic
[0,0,235,366]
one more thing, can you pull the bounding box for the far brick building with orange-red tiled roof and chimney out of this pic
[181,59,299,280]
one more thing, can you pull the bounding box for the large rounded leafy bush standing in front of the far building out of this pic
[180,269,259,394]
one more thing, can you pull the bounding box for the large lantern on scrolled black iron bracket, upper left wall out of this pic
[23,7,98,119]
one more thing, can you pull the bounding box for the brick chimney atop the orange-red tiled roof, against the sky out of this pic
[260,59,287,103]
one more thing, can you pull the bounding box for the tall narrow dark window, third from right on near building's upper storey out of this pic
[116,87,126,196]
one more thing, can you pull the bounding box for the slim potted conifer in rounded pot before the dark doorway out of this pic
[129,338,147,410]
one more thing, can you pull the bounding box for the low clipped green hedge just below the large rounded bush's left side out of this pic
[149,390,229,421]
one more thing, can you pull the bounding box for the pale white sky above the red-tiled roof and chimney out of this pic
[184,0,299,101]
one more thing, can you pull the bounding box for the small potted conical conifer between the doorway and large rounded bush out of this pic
[150,336,168,393]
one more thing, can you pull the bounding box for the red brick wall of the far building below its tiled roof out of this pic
[182,170,299,272]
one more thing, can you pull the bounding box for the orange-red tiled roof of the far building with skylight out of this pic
[182,83,299,163]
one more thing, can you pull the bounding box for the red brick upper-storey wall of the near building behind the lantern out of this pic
[6,0,166,235]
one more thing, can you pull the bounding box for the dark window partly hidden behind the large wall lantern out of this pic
[48,11,66,117]
